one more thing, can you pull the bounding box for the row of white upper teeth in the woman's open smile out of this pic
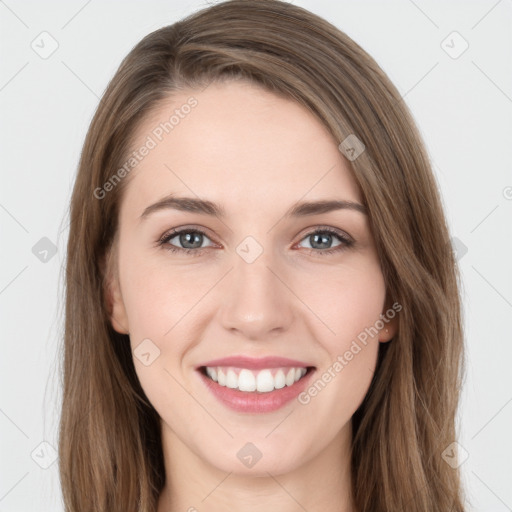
[206,366,307,393]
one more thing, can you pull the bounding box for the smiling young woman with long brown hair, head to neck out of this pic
[60,0,463,512]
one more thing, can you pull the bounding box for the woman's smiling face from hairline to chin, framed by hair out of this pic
[110,82,395,475]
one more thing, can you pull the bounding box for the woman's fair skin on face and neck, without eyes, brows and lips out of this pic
[109,81,396,512]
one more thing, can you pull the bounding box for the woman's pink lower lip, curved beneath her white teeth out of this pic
[199,370,315,413]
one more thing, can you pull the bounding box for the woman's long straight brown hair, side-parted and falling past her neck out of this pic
[59,0,463,512]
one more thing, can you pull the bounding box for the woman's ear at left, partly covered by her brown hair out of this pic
[104,241,130,334]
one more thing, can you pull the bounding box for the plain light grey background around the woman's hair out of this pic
[0,0,512,512]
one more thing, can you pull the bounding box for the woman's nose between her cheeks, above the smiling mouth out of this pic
[220,247,297,340]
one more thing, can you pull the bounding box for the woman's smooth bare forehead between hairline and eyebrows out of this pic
[123,82,361,220]
